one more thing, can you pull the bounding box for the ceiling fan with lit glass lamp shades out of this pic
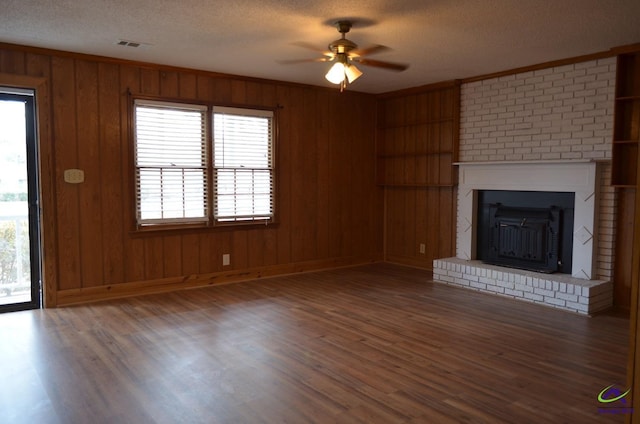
[280,20,409,91]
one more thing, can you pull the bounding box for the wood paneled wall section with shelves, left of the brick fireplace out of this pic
[377,82,460,269]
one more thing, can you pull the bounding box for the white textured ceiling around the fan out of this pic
[0,0,640,93]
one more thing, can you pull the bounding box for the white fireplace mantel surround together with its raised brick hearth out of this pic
[433,160,612,313]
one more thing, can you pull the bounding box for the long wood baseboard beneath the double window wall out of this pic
[56,255,382,307]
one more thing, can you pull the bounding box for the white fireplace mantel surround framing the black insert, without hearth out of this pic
[456,160,597,280]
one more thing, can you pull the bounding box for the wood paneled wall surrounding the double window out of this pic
[0,45,383,306]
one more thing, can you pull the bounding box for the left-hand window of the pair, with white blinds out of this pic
[134,99,208,225]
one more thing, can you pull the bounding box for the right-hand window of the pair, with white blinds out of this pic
[213,106,274,223]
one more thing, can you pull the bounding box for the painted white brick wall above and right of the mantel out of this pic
[460,57,616,280]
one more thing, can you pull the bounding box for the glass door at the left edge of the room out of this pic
[0,87,42,312]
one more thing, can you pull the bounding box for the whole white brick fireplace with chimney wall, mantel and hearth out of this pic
[433,58,615,314]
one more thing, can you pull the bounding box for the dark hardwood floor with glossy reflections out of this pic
[0,264,628,424]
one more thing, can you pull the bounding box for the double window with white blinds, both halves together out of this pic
[134,99,274,226]
